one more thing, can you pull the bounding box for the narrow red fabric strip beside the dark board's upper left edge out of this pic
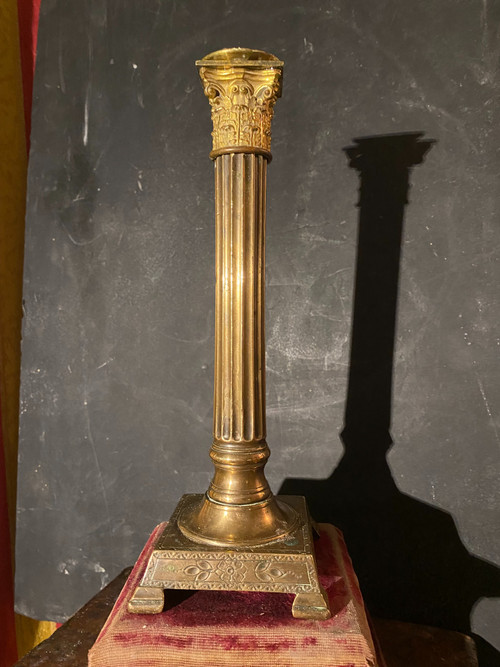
[17,0,41,152]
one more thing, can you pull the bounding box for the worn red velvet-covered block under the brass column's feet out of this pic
[89,523,382,667]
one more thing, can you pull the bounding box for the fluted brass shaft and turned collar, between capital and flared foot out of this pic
[208,153,271,503]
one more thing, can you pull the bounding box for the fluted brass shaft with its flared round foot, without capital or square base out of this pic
[179,153,297,546]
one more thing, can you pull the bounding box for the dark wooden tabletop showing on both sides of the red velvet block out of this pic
[17,568,478,667]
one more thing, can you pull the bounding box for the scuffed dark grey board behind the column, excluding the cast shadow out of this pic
[16,0,500,664]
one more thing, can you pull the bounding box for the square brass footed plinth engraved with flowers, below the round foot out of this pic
[128,494,331,620]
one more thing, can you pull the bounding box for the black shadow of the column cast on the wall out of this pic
[279,132,500,667]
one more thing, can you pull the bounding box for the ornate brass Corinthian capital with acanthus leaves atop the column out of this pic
[196,48,283,159]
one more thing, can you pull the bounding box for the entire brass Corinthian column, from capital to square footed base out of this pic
[129,48,330,619]
